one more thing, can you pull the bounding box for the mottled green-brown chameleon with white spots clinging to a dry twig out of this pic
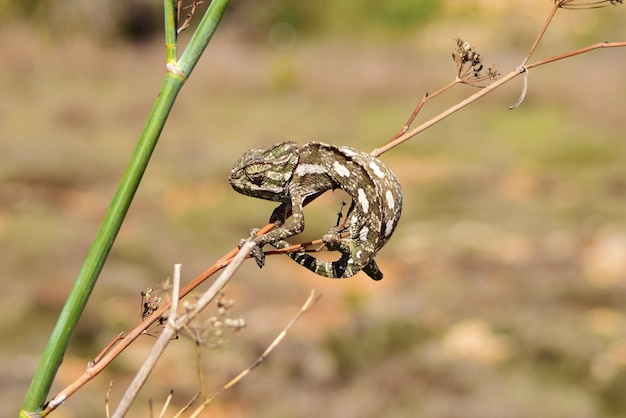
[229,141,402,280]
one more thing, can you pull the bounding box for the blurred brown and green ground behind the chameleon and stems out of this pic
[0,0,626,418]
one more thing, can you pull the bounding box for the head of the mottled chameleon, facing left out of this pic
[228,142,300,201]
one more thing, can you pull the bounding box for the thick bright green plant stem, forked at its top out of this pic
[20,0,230,417]
